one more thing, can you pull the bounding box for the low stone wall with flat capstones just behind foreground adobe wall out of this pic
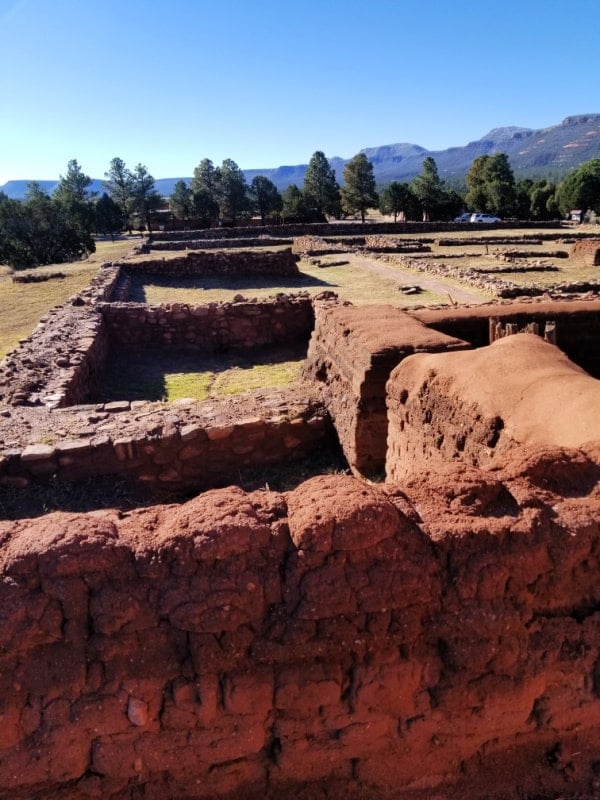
[0,387,333,500]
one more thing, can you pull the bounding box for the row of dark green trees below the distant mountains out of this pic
[0,151,600,268]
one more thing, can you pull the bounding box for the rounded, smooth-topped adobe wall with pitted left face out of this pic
[386,333,600,481]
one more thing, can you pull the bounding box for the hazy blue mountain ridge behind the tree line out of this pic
[0,114,600,199]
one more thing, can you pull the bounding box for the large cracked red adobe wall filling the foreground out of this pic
[0,468,600,800]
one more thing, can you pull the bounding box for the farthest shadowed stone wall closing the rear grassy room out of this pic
[115,248,299,277]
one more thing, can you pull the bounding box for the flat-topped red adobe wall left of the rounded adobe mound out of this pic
[304,302,470,476]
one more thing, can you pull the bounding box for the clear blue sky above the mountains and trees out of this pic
[0,0,600,185]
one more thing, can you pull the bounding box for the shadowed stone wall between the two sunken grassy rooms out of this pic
[98,294,314,353]
